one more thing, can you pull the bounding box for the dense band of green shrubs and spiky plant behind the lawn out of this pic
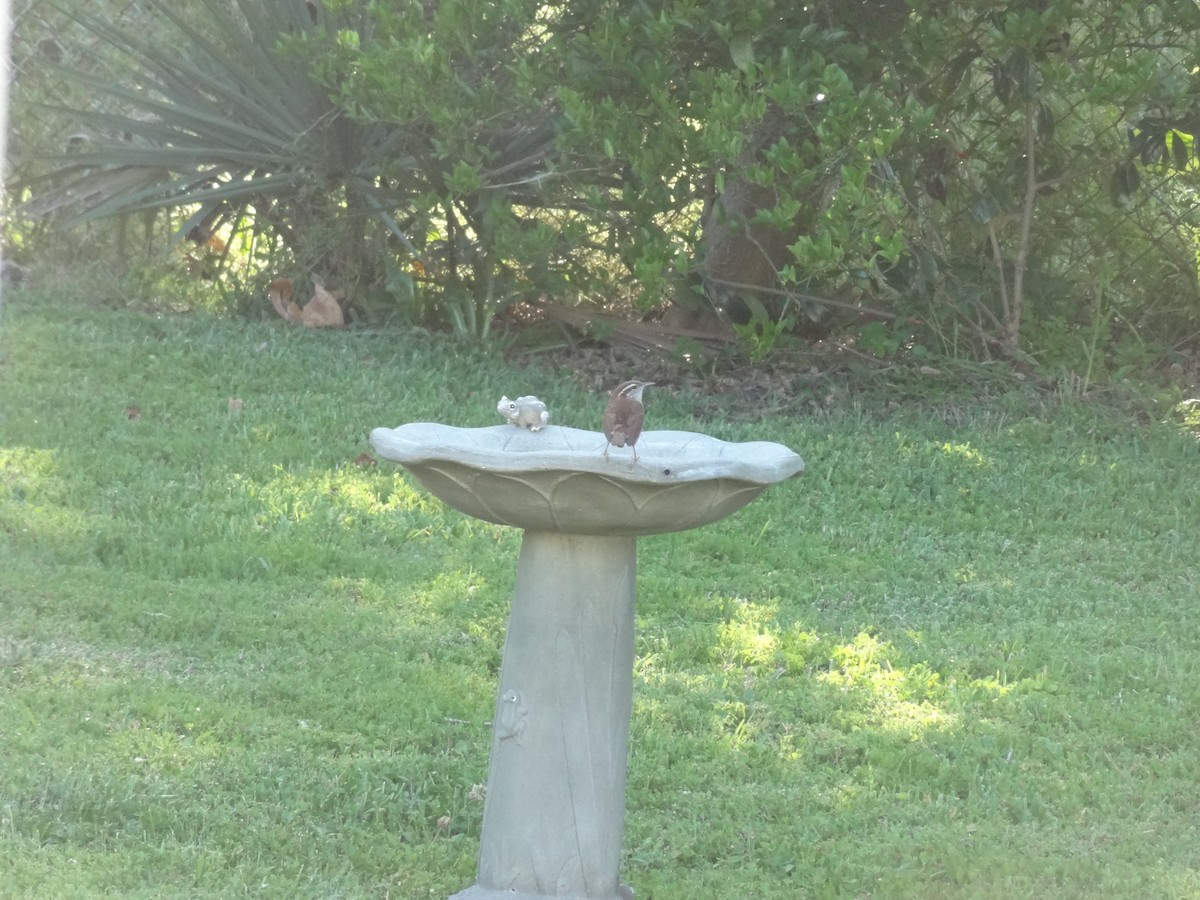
[10,0,1200,372]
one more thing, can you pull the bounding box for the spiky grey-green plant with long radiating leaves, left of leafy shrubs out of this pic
[19,0,418,300]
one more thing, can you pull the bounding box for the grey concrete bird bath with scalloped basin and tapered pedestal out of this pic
[371,422,804,900]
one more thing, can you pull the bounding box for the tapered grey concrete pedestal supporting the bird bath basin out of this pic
[455,532,637,900]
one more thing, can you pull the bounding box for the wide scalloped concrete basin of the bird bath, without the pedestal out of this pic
[371,422,804,534]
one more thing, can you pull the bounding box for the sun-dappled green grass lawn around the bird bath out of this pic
[0,294,1200,900]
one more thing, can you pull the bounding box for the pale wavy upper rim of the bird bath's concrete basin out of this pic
[371,422,804,486]
